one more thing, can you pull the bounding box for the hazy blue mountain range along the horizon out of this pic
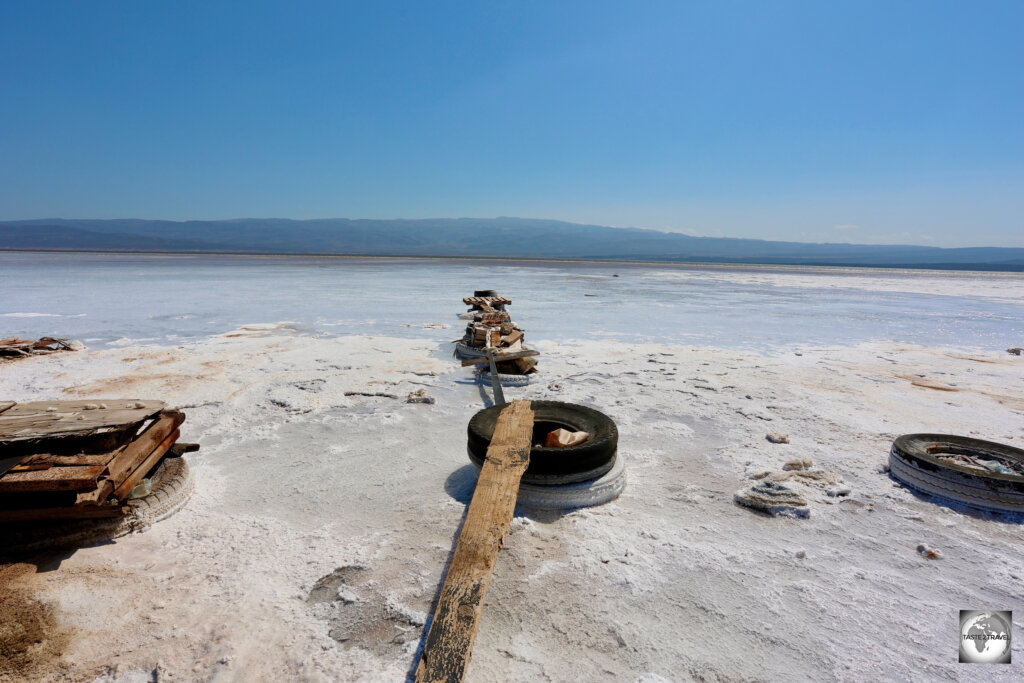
[0,218,1024,271]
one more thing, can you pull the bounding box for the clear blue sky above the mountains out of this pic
[0,0,1024,246]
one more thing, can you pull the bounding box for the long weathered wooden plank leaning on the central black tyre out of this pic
[416,400,534,683]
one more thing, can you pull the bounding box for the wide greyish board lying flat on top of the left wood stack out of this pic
[0,398,165,443]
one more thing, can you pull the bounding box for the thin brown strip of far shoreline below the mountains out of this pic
[0,247,1024,273]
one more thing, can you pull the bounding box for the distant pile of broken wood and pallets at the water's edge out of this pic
[456,296,538,375]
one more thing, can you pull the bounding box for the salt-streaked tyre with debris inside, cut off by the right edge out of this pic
[889,434,1024,512]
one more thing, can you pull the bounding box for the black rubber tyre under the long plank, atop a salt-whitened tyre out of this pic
[467,400,618,475]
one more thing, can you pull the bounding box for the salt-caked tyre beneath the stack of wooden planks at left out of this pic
[0,457,193,557]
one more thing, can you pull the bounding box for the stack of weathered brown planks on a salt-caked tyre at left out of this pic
[0,399,198,522]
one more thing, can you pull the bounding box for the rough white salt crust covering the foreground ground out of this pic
[0,324,1024,681]
